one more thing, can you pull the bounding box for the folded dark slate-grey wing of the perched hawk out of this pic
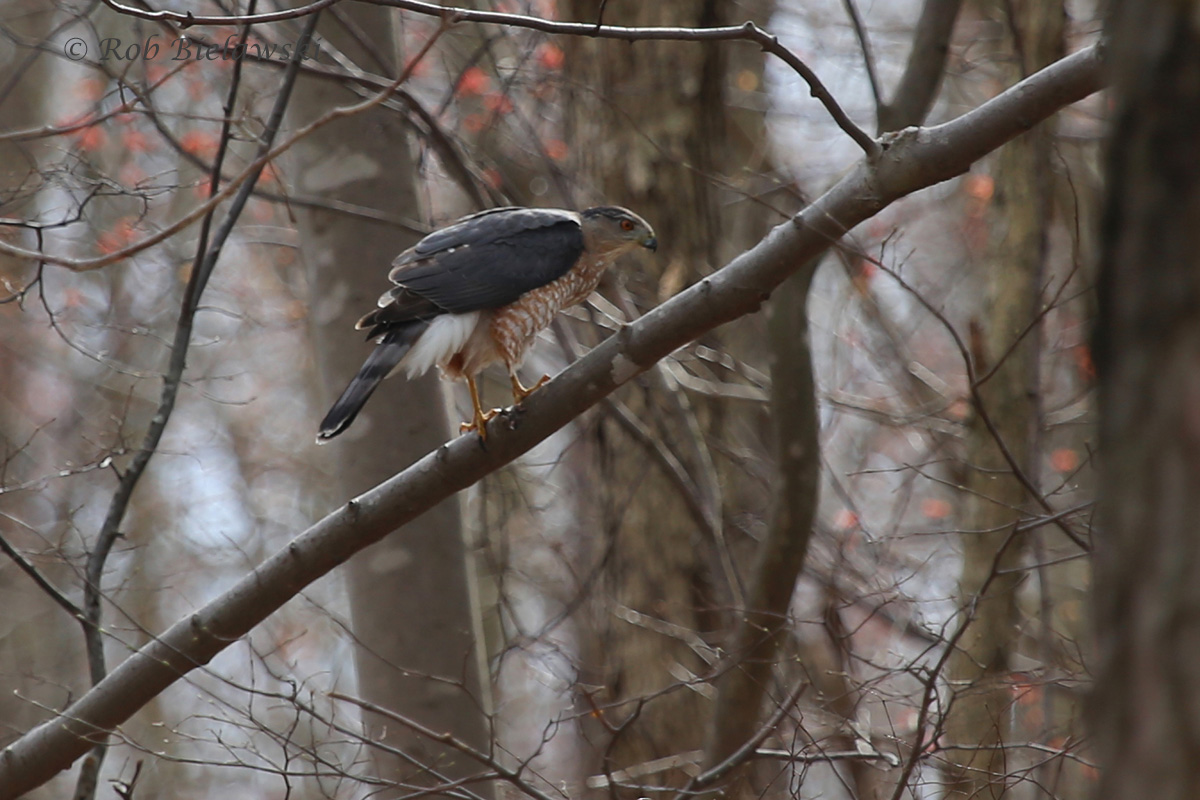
[388,207,583,313]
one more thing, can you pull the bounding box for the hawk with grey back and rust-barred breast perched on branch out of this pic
[317,205,658,444]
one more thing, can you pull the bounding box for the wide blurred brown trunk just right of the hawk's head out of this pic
[560,0,772,784]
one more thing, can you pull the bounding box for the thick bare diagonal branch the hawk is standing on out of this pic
[0,47,1103,800]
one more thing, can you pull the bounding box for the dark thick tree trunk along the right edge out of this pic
[1093,0,1200,800]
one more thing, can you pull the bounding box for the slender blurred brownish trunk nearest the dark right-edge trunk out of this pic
[946,2,1064,798]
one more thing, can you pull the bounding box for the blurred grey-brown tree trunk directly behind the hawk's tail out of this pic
[292,6,488,780]
